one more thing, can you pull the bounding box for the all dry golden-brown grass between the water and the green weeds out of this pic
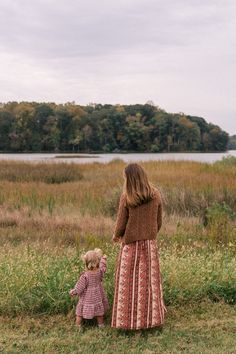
[0,161,236,243]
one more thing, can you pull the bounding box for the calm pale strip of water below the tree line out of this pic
[0,150,236,163]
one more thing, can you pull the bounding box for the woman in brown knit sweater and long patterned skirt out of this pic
[111,163,165,330]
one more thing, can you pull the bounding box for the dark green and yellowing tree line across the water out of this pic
[0,102,229,152]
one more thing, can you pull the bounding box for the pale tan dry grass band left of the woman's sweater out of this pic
[0,207,114,247]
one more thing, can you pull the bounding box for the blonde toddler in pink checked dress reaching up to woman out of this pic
[70,248,108,327]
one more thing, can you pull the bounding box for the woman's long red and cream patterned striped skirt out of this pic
[111,240,166,330]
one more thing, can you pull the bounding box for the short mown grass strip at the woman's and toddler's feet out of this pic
[0,302,236,354]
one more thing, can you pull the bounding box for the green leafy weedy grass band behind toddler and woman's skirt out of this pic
[0,241,236,315]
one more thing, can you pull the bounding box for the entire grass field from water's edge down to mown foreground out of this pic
[0,159,236,354]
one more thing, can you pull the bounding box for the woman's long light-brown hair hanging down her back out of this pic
[124,163,156,207]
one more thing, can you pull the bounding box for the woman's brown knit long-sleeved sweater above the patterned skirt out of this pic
[114,191,162,244]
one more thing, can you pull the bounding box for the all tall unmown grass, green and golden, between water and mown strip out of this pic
[0,161,236,316]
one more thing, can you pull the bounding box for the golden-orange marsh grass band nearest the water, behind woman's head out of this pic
[0,161,236,216]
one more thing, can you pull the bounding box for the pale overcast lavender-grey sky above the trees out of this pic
[0,0,236,134]
